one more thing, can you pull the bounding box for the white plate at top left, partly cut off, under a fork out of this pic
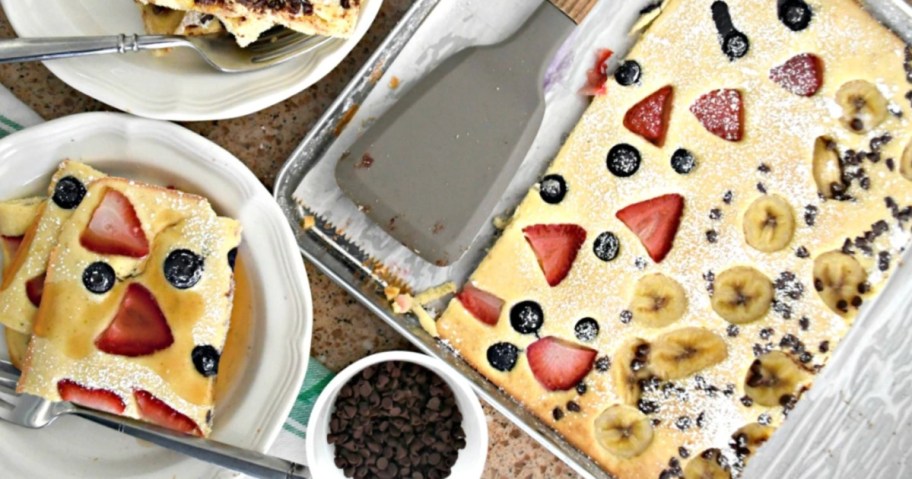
[0,0,382,121]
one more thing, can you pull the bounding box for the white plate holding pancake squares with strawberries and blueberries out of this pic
[0,113,313,478]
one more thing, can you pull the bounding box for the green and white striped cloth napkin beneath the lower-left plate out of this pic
[0,82,333,464]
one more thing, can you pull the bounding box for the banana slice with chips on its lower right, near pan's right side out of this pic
[814,251,868,315]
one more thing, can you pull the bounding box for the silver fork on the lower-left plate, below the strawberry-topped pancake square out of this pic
[0,360,311,479]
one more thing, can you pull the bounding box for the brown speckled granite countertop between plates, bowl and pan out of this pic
[0,0,576,479]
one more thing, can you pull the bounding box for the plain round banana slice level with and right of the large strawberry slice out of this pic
[744,195,795,253]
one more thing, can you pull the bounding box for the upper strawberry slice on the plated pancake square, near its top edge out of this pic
[79,190,149,258]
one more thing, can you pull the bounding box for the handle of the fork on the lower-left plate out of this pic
[76,407,311,479]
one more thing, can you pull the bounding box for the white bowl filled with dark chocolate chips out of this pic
[306,351,488,479]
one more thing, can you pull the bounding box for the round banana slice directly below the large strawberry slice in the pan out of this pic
[630,273,687,328]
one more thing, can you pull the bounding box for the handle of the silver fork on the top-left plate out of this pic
[0,34,186,63]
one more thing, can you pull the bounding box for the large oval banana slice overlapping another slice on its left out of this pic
[649,328,728,381]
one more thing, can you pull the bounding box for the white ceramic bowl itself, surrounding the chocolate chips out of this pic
[305,351,488,479]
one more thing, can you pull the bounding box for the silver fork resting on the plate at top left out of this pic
[0,28,334,73]
